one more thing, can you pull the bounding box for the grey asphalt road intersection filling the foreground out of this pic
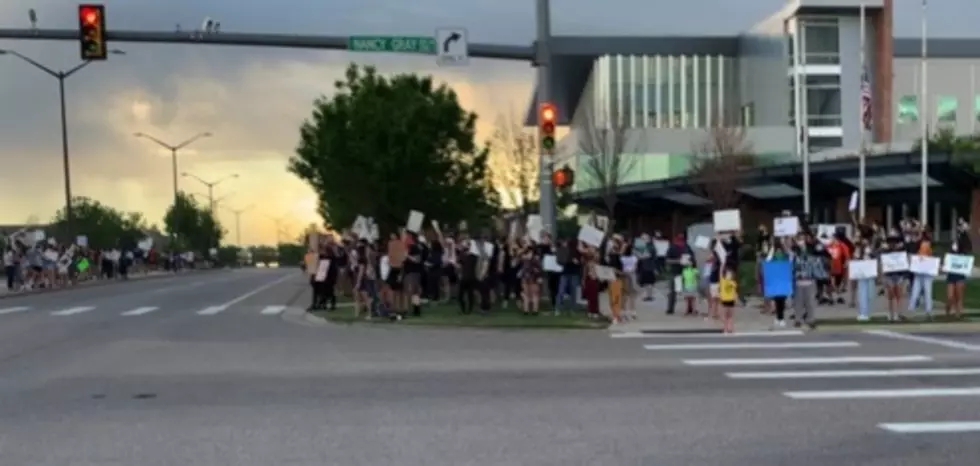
[0,270,980,466]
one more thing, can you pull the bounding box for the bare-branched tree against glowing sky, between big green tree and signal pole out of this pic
[491,115,540,215]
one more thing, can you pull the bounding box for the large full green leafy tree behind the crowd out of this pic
[289,64,499,237]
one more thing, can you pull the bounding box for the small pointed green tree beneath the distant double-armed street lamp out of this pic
[163,192,225,254]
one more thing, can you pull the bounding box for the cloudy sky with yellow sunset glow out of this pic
[0,0,980,244]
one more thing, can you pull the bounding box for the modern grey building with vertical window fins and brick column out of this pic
[527,0,980,240]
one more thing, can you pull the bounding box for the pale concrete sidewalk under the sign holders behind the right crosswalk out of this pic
[602,280,971,333]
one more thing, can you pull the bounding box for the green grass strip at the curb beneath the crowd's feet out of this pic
[316,302,609,329]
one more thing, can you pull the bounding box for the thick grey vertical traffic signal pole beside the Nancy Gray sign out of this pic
[535,0,557,238]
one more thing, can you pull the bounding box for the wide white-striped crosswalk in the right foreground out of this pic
[611,330,980,435]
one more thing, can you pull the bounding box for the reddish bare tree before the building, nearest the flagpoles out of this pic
[688,127,757,210]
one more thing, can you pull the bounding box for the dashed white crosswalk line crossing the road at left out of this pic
[0,304,289,322]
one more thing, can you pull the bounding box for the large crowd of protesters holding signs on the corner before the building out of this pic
[306,212,972,331]
